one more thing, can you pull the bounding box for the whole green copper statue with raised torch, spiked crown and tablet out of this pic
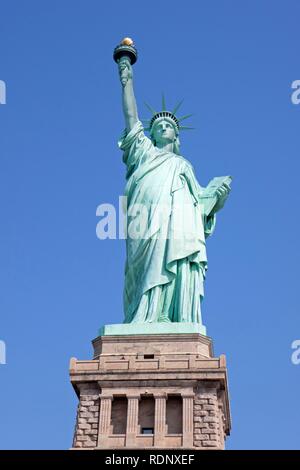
[114,38,231,326]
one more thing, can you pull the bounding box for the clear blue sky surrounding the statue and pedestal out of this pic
[0,0,300,449]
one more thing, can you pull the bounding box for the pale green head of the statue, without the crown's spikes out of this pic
[150,117,180,154]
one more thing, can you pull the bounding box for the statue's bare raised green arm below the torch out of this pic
[118,56,139,132]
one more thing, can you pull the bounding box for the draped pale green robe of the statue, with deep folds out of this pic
[119,122,215,324]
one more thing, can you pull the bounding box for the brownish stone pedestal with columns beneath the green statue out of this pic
[70,333,230,450]
